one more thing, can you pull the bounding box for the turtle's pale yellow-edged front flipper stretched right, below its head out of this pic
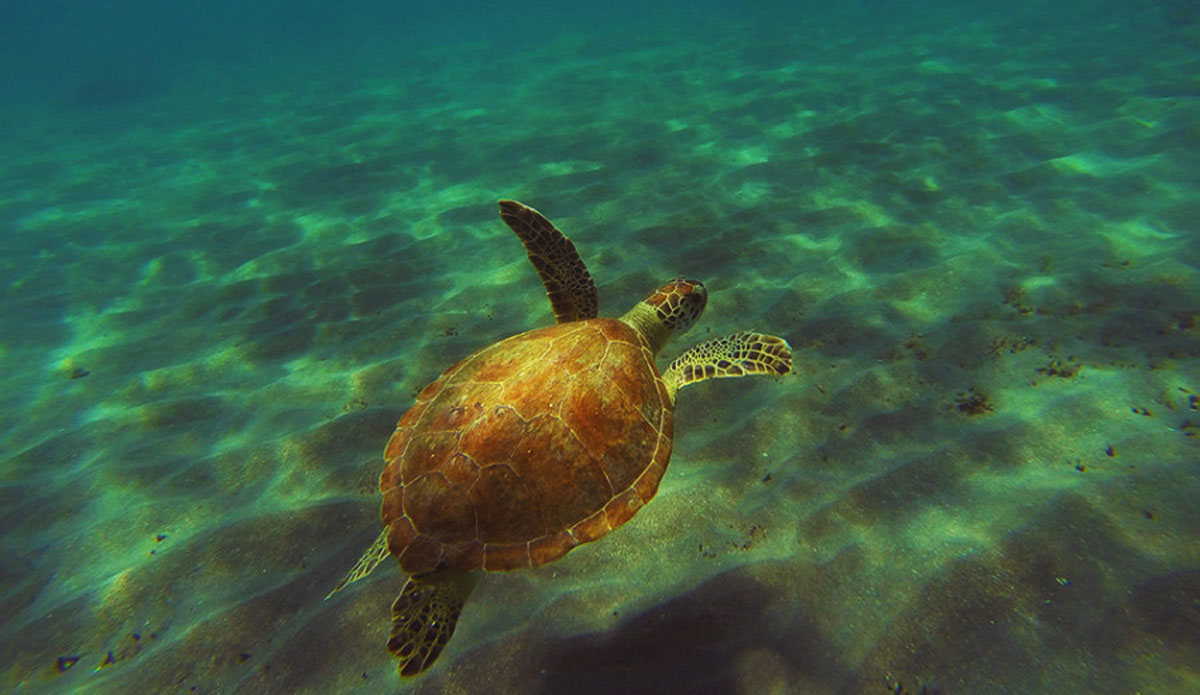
[662,331,792,401]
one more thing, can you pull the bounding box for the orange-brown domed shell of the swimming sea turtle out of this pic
[379,318,672,575]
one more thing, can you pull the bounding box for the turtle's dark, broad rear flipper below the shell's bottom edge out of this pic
[388,570,480,676]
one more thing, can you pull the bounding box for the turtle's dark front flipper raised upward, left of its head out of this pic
[500,200,599,323]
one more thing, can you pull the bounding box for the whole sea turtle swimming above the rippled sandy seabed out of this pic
[325,200,792,676]
